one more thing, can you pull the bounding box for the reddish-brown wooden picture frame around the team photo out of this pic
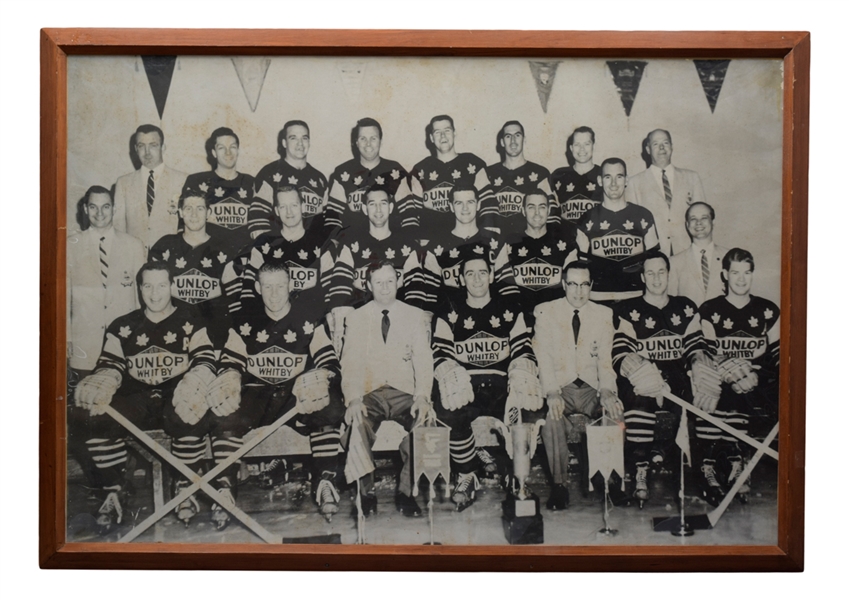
[39,29,810,571]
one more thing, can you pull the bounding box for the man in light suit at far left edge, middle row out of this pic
[68,185,145,379]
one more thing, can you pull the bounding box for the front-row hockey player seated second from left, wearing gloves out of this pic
[217,262,345,521]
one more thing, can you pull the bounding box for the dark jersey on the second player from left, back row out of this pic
[248,159,328,238]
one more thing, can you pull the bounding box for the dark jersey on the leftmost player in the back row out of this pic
[180,171,254,255]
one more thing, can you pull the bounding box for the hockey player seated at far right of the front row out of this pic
[693,248,780,506]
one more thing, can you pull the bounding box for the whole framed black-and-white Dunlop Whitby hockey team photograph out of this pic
[40,29,810,571]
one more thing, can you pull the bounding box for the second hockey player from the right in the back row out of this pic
[476,121,560,237]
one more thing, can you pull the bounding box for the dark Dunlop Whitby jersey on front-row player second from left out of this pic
[220,302,341,386]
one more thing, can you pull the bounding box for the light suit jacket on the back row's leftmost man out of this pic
[112,166,186,249]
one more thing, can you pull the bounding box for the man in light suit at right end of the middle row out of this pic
[669,202,728,306]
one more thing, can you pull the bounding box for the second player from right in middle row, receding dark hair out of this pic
[507,191,578,314]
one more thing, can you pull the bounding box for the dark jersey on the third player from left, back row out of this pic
[325,158,407,228]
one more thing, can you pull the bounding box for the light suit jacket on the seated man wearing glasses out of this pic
[533,298,616,394]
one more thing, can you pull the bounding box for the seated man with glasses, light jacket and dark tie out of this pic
[523,261,623,510]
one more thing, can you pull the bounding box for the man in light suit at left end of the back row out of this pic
[115,125,186,249]
